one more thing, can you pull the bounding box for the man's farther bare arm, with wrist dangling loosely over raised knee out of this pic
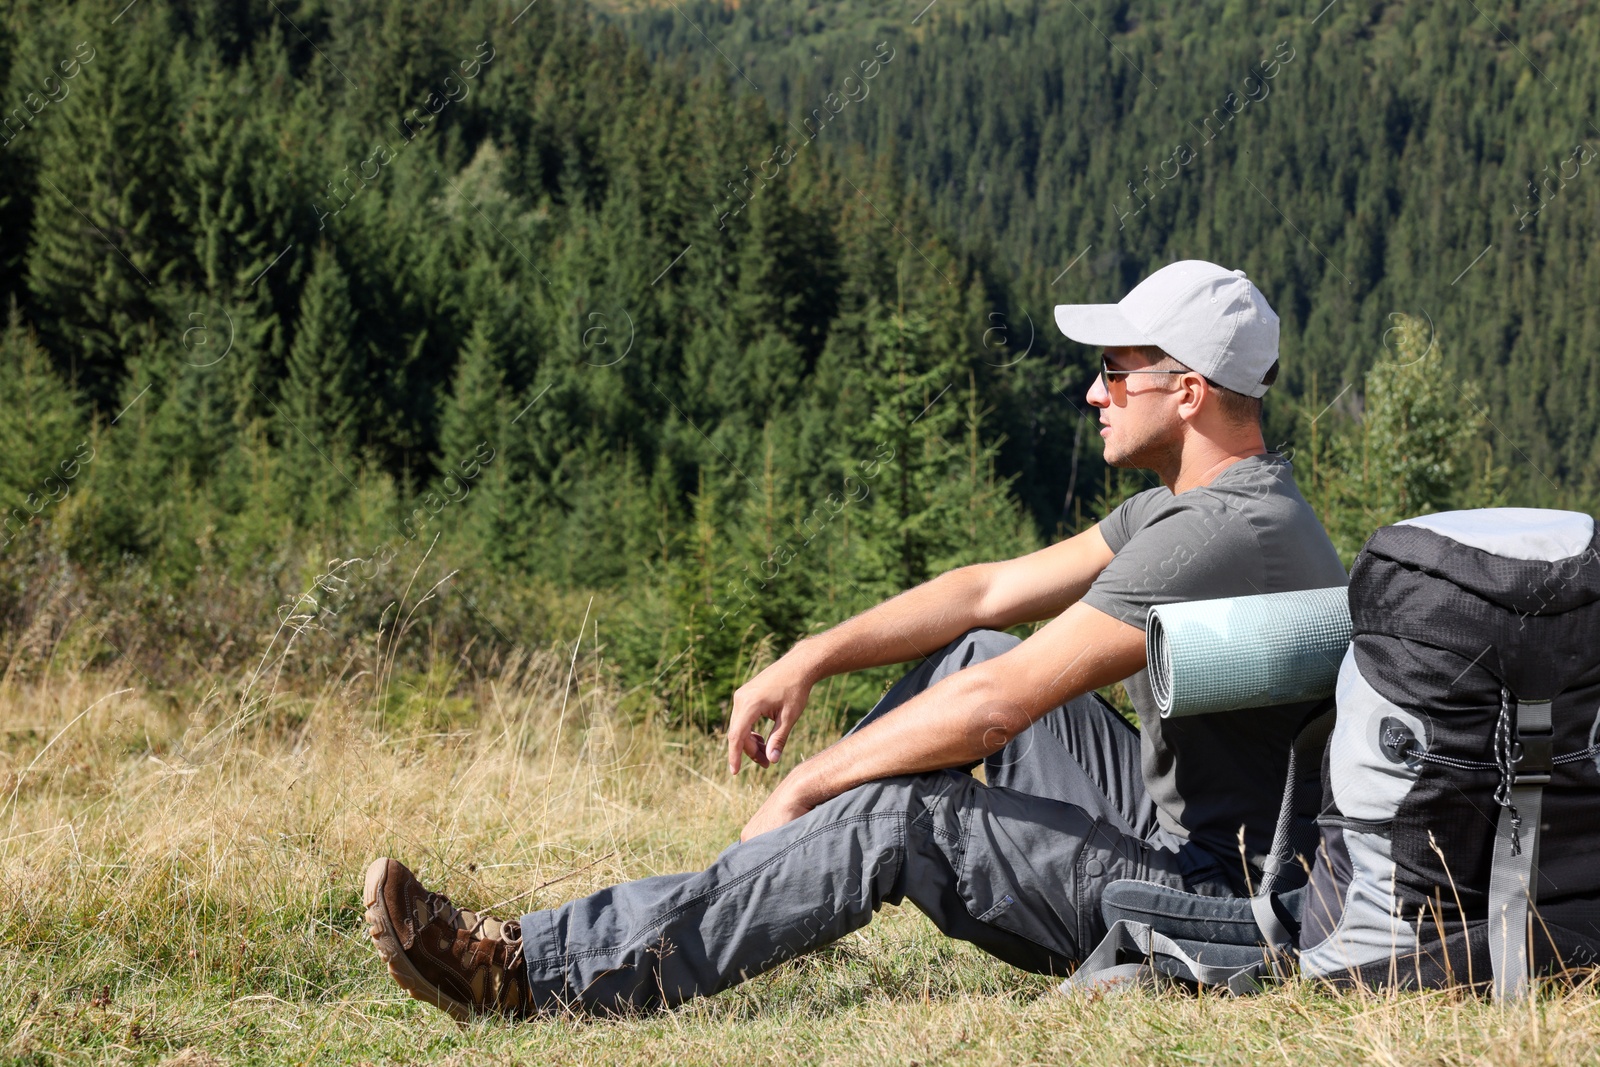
[728,526,1112,774]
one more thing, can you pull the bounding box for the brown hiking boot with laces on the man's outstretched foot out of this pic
[362,859,534,1022]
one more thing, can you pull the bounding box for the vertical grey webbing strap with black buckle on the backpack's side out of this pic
[1488,691,1554,1003]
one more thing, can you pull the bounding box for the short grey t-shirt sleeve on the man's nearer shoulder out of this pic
[1083,498,1262,630]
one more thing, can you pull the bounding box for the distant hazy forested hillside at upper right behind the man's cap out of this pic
[622,0,1600,506]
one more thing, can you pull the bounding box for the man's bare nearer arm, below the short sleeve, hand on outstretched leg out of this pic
[741,603,1146,841]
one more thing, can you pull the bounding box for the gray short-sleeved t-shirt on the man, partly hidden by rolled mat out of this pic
[1083,453,1349,877]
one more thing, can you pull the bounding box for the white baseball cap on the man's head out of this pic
[1056,259,1278,397]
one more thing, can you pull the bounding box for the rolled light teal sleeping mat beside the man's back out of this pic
[1144,585,1350,718]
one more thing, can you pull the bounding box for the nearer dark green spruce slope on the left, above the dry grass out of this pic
[0,0,1049,715]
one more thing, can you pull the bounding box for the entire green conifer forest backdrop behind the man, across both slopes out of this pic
[0,0,1600,723]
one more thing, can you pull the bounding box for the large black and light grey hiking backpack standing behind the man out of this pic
[1062,509,1600,1000]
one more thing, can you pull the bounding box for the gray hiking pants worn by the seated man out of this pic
[522,630,1232,1011]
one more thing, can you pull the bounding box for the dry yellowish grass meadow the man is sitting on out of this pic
[0,654,1600,1067]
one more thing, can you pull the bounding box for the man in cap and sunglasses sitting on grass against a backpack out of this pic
[365,261,1346,1019]
